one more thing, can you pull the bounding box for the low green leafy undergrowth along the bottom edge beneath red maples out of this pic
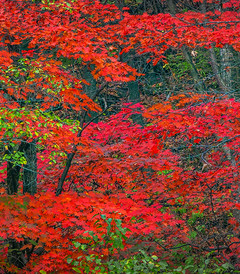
[67,216,237,274]
